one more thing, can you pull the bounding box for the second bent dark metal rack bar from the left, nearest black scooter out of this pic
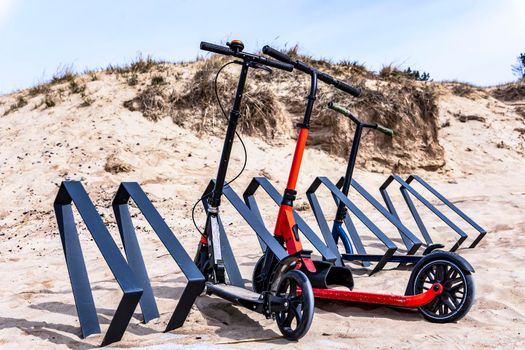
[113,182,205,332]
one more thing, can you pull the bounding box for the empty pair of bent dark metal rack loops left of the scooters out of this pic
[54,181,204,346]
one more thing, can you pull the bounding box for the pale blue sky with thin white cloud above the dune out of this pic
[0,0,525,93]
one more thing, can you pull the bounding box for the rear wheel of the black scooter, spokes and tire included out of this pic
[275,270,314,340]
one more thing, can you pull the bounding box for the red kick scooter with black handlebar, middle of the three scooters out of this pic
[253,46,474,323]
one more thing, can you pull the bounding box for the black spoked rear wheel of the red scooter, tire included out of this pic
[407,252,475,323]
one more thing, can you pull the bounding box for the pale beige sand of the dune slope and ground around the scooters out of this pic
[0,75,525,349]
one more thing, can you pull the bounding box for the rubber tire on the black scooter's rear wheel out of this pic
[276,270,315,340]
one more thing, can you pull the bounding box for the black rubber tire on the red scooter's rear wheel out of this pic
[407,251,476,323]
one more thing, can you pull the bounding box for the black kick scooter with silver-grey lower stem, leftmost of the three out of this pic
[195,40,314,340]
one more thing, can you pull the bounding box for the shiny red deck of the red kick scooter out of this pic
[313,283,443,307]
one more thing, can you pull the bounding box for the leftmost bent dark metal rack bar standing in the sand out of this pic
[54,181,143,345]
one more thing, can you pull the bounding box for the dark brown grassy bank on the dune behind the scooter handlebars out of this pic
[119,52,445,171]
